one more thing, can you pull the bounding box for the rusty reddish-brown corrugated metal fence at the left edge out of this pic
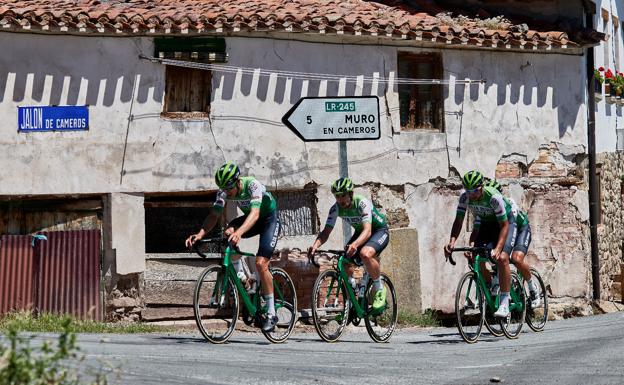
[0,230,103,320]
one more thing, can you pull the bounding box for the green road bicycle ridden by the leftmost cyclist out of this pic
[193,238,297,344]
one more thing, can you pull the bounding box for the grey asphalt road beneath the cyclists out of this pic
[22,313,624,385]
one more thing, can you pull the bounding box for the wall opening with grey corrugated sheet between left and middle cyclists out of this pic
[271,188,319,236]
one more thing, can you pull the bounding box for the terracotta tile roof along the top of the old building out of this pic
[0,0,598,50]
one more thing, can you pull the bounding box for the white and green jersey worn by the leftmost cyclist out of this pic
[213,176,277,218]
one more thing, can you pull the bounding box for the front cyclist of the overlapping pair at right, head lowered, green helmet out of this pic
[444,170,517,318]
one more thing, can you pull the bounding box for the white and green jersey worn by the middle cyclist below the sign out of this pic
[325,195,388,233]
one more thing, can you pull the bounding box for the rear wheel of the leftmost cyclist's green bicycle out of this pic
[261,267,297,344]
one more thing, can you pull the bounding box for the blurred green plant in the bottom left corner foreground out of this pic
[0,318,113,385]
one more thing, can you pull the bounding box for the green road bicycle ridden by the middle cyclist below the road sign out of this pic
[308,250,398,342]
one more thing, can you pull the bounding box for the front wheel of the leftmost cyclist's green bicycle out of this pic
[193,265,238,344]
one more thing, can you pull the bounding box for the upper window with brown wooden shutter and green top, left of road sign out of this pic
[154,37,228,118]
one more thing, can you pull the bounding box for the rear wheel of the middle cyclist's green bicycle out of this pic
[364,273,399,342]
